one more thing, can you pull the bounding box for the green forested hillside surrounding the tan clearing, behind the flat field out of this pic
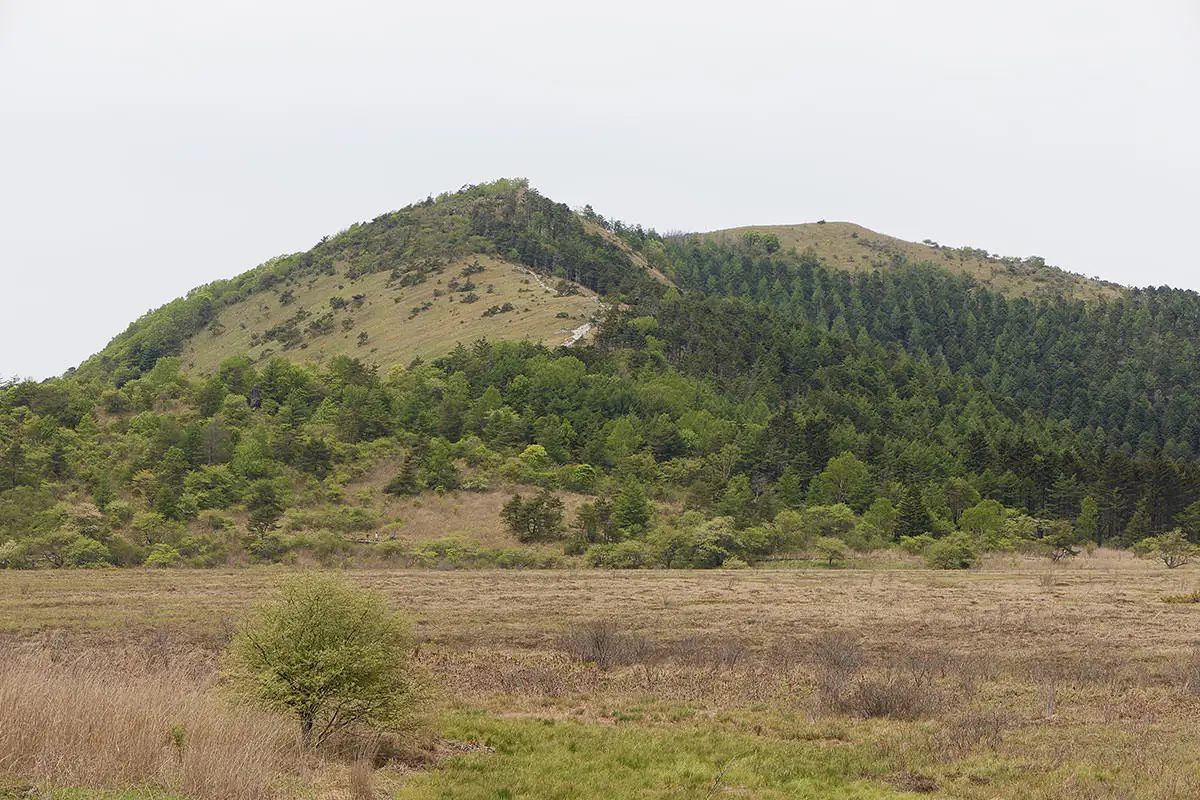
[0,181,1200,567]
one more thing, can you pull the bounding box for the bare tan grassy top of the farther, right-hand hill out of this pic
[703,222,1124,300]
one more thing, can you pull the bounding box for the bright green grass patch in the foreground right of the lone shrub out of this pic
[395,712,913,800]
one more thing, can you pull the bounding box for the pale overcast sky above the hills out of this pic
[0,0,1200,378]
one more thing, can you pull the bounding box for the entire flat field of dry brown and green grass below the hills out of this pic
[0,551,1200,800]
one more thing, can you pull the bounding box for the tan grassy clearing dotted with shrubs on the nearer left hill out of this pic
[181,255,601,375]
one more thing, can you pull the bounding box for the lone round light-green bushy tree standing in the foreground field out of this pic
[224,575,414,746]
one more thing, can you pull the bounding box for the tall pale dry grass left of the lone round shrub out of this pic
[0,648,299,800]
